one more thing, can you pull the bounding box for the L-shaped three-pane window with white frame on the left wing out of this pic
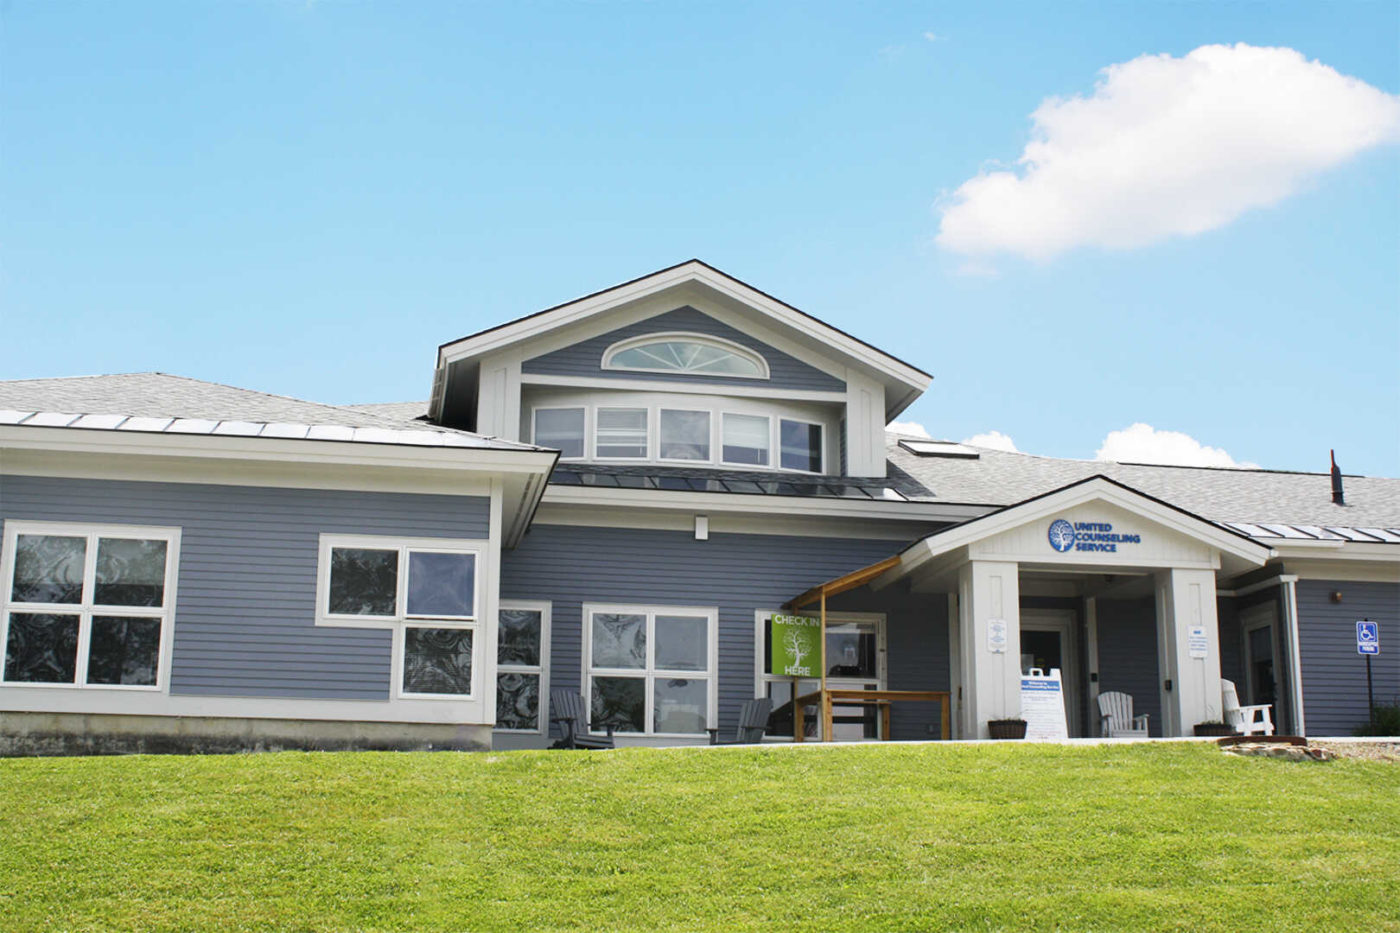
[318,535,480,699]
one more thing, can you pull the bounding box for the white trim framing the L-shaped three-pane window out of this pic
[315,534,496,703]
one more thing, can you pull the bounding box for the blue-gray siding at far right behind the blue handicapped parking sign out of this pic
[1296,580,1400,735]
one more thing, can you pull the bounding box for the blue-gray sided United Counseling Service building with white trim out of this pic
[0,261,1400,754]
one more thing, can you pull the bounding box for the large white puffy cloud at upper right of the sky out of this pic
[938,45,1400,259]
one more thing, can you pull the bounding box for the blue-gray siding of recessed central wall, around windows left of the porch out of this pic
[501,525,896,730]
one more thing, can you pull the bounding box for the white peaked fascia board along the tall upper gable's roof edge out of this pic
[438,262,931,392]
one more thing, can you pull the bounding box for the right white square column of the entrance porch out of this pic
[1156,570,1225,735]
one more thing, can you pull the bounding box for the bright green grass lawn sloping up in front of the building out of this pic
[0,744,1400,932]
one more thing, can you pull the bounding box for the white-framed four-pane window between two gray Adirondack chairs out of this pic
[584,605,718,735]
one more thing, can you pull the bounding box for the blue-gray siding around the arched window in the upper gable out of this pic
[521,307,846,394]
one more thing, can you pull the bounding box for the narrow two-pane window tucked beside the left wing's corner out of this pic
[496,601,550,733]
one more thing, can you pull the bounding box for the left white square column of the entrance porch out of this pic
[958,560,1021,738]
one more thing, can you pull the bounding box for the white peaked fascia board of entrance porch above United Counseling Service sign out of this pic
[897,479,1274,576]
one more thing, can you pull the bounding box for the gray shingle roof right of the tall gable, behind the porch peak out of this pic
[886,434,1400,528]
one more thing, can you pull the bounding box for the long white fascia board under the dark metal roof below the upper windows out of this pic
[543,485,987,523]
